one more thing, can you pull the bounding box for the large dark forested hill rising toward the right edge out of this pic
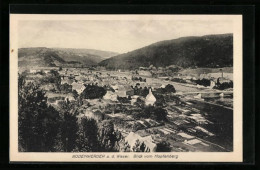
[99,34,233,69]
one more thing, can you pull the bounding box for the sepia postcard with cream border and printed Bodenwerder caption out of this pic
[10,14,242,162]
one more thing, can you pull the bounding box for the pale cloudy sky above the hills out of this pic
[18,20,233,53]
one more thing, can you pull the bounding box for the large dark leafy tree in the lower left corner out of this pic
[18,81,60,152]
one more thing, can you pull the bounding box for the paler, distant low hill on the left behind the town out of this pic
[18,47,118,67]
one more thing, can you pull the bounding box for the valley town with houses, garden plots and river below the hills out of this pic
[19,65,233,152]
